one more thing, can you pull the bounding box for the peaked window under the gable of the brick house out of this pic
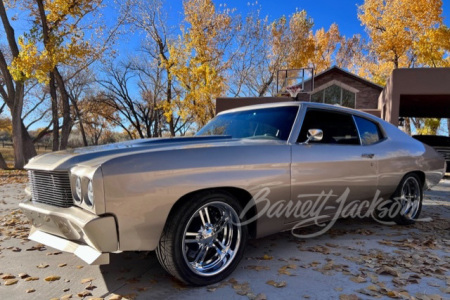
[311,84,356,108]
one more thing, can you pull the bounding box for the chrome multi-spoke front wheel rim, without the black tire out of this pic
[181,201,242,276]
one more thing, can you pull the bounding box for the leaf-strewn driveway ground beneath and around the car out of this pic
[0,179,450,299]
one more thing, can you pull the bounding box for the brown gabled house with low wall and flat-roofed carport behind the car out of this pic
[216,66,450,126]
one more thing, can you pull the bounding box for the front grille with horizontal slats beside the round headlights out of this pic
[28,170,73,207]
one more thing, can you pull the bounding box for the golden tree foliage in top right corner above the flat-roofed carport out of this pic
[358,0,450,84]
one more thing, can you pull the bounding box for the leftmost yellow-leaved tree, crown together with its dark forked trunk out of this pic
[8,0,104,150]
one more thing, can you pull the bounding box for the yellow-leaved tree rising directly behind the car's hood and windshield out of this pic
[163,0,233,126]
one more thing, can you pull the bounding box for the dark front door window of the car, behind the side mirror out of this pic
[297,109,360,145]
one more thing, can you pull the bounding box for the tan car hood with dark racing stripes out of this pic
[25,136,274,171]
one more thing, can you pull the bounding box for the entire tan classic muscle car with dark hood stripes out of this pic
[20,102,445,285]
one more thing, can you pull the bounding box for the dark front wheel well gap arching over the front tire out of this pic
[169,187,257,238]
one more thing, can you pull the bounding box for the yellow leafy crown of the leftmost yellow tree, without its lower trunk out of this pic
[9,0,102,84]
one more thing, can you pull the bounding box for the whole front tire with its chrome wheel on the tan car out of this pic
[156,192,248,285]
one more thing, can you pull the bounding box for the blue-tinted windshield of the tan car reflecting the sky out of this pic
[196,106,298,141]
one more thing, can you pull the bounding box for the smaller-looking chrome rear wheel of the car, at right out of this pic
[399,176,422,220]
